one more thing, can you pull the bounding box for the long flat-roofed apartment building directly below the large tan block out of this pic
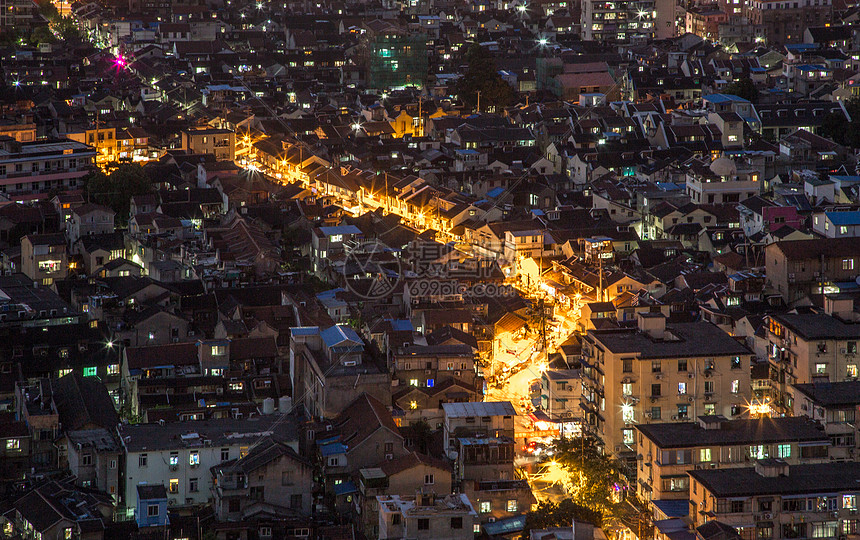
[636,416,830,501]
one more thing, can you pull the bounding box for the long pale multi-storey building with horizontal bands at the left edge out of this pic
[0,138,96,200]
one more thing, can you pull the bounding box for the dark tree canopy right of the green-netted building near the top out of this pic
[454,43,516,111]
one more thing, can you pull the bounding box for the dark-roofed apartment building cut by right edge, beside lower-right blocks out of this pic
[790,379,860,461]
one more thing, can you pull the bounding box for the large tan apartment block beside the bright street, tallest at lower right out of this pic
[582,313,754,466]
